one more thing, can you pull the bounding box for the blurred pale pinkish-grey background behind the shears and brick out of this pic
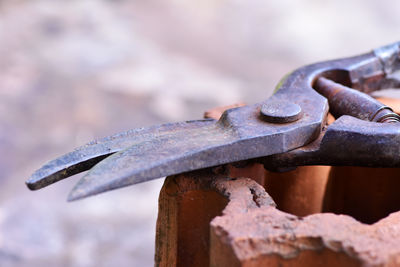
[0,0,400,266]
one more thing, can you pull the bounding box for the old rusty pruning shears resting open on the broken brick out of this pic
[26,42,400,200]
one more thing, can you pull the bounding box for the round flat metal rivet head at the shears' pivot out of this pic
[260,100,302,123]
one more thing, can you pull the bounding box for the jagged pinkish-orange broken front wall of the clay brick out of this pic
[210,188,400,266]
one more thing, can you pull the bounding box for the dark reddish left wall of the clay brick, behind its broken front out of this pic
[155,173,274,266]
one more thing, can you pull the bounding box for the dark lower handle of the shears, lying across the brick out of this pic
[259,116,400,170]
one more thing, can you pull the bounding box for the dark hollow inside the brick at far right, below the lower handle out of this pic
[322,167,400,224]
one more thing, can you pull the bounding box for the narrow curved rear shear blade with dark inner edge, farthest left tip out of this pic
[26,120,215,190]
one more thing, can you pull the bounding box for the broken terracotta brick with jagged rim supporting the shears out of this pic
[156,166,400,267]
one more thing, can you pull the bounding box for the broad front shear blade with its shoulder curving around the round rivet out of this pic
[68,99,327,201]
